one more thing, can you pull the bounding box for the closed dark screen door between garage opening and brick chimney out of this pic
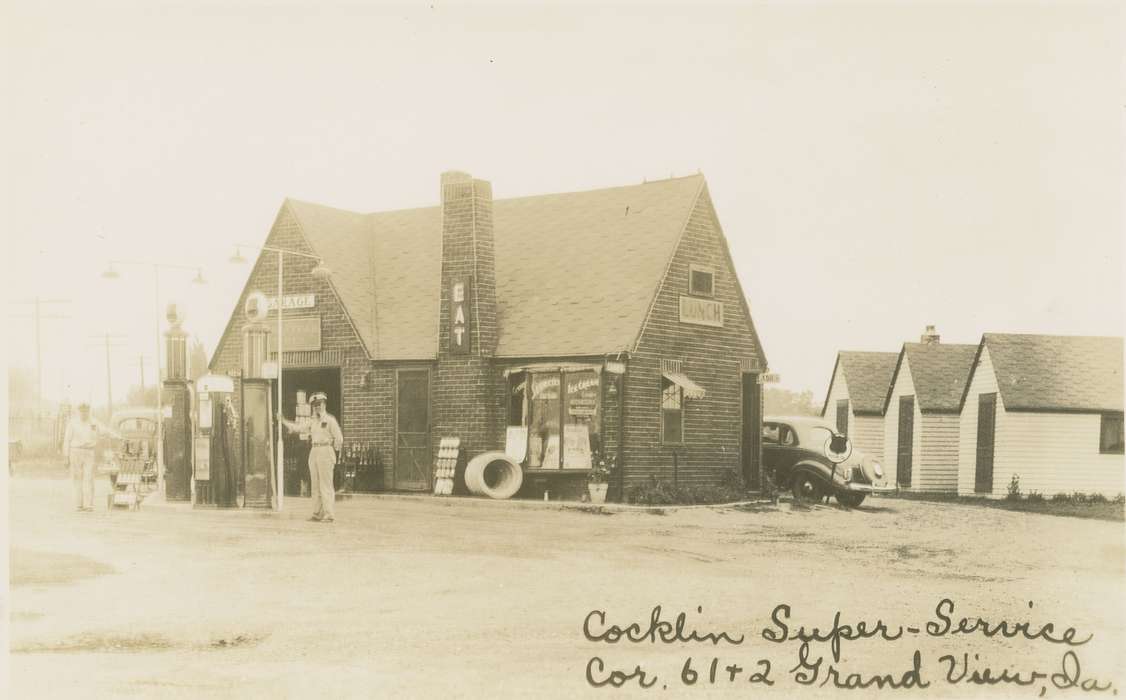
[394,369,430,491]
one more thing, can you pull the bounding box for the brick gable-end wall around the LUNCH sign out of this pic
[625,188,765,488]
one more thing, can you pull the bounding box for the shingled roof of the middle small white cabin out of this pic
[884,343,977,413]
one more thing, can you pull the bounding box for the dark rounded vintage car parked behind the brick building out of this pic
[762,415,895,508]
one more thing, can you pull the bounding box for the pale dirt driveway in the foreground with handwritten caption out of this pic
[9,478,1126,698]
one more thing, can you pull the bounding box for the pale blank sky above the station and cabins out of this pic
[0,0,1126,411]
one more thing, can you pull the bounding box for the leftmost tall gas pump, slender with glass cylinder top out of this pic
[161,304,193,501]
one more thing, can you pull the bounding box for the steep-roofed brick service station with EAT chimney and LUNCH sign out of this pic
[211,172,767,496]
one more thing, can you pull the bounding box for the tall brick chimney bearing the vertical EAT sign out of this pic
[432,171,499,457]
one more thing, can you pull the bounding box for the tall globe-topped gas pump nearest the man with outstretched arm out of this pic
[239,291,277,508]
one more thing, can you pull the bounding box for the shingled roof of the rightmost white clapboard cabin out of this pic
[963,333,1123,413]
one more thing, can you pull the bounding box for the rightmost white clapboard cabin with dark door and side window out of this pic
[958,333,1126,497]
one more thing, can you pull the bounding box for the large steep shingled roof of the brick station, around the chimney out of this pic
[284,174,705,360]
